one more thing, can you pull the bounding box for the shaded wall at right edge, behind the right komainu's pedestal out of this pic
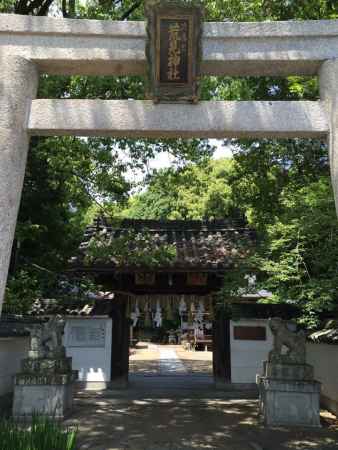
[306,342,338,416]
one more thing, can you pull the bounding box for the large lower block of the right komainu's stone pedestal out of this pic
[257,377,320,427]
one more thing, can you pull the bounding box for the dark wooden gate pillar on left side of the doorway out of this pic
[110,295,130,389]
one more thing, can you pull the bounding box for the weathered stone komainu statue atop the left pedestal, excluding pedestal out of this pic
[28,316,65,358]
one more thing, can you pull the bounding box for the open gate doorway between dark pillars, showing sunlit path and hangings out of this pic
[129,295,214,387]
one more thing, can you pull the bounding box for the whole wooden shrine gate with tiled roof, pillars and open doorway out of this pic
[68,217,244,384]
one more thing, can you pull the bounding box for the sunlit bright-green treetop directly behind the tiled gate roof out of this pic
[122,159,238,220]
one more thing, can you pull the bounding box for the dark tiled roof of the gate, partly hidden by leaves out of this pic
[71,217,255,271]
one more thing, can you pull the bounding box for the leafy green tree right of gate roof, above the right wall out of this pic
[258,177,338,327]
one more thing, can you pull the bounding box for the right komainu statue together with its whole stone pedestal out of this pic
[257,319,320,427]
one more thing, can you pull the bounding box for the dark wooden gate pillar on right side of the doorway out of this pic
[213,314,231,387]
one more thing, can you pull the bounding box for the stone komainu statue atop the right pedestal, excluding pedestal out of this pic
[269,318,306,364]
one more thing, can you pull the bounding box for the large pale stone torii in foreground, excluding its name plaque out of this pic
[0,14,338,314]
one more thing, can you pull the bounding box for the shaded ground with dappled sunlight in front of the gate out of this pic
[67,385,338,450]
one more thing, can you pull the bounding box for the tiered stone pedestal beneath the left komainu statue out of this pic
[13,357,77,420]
